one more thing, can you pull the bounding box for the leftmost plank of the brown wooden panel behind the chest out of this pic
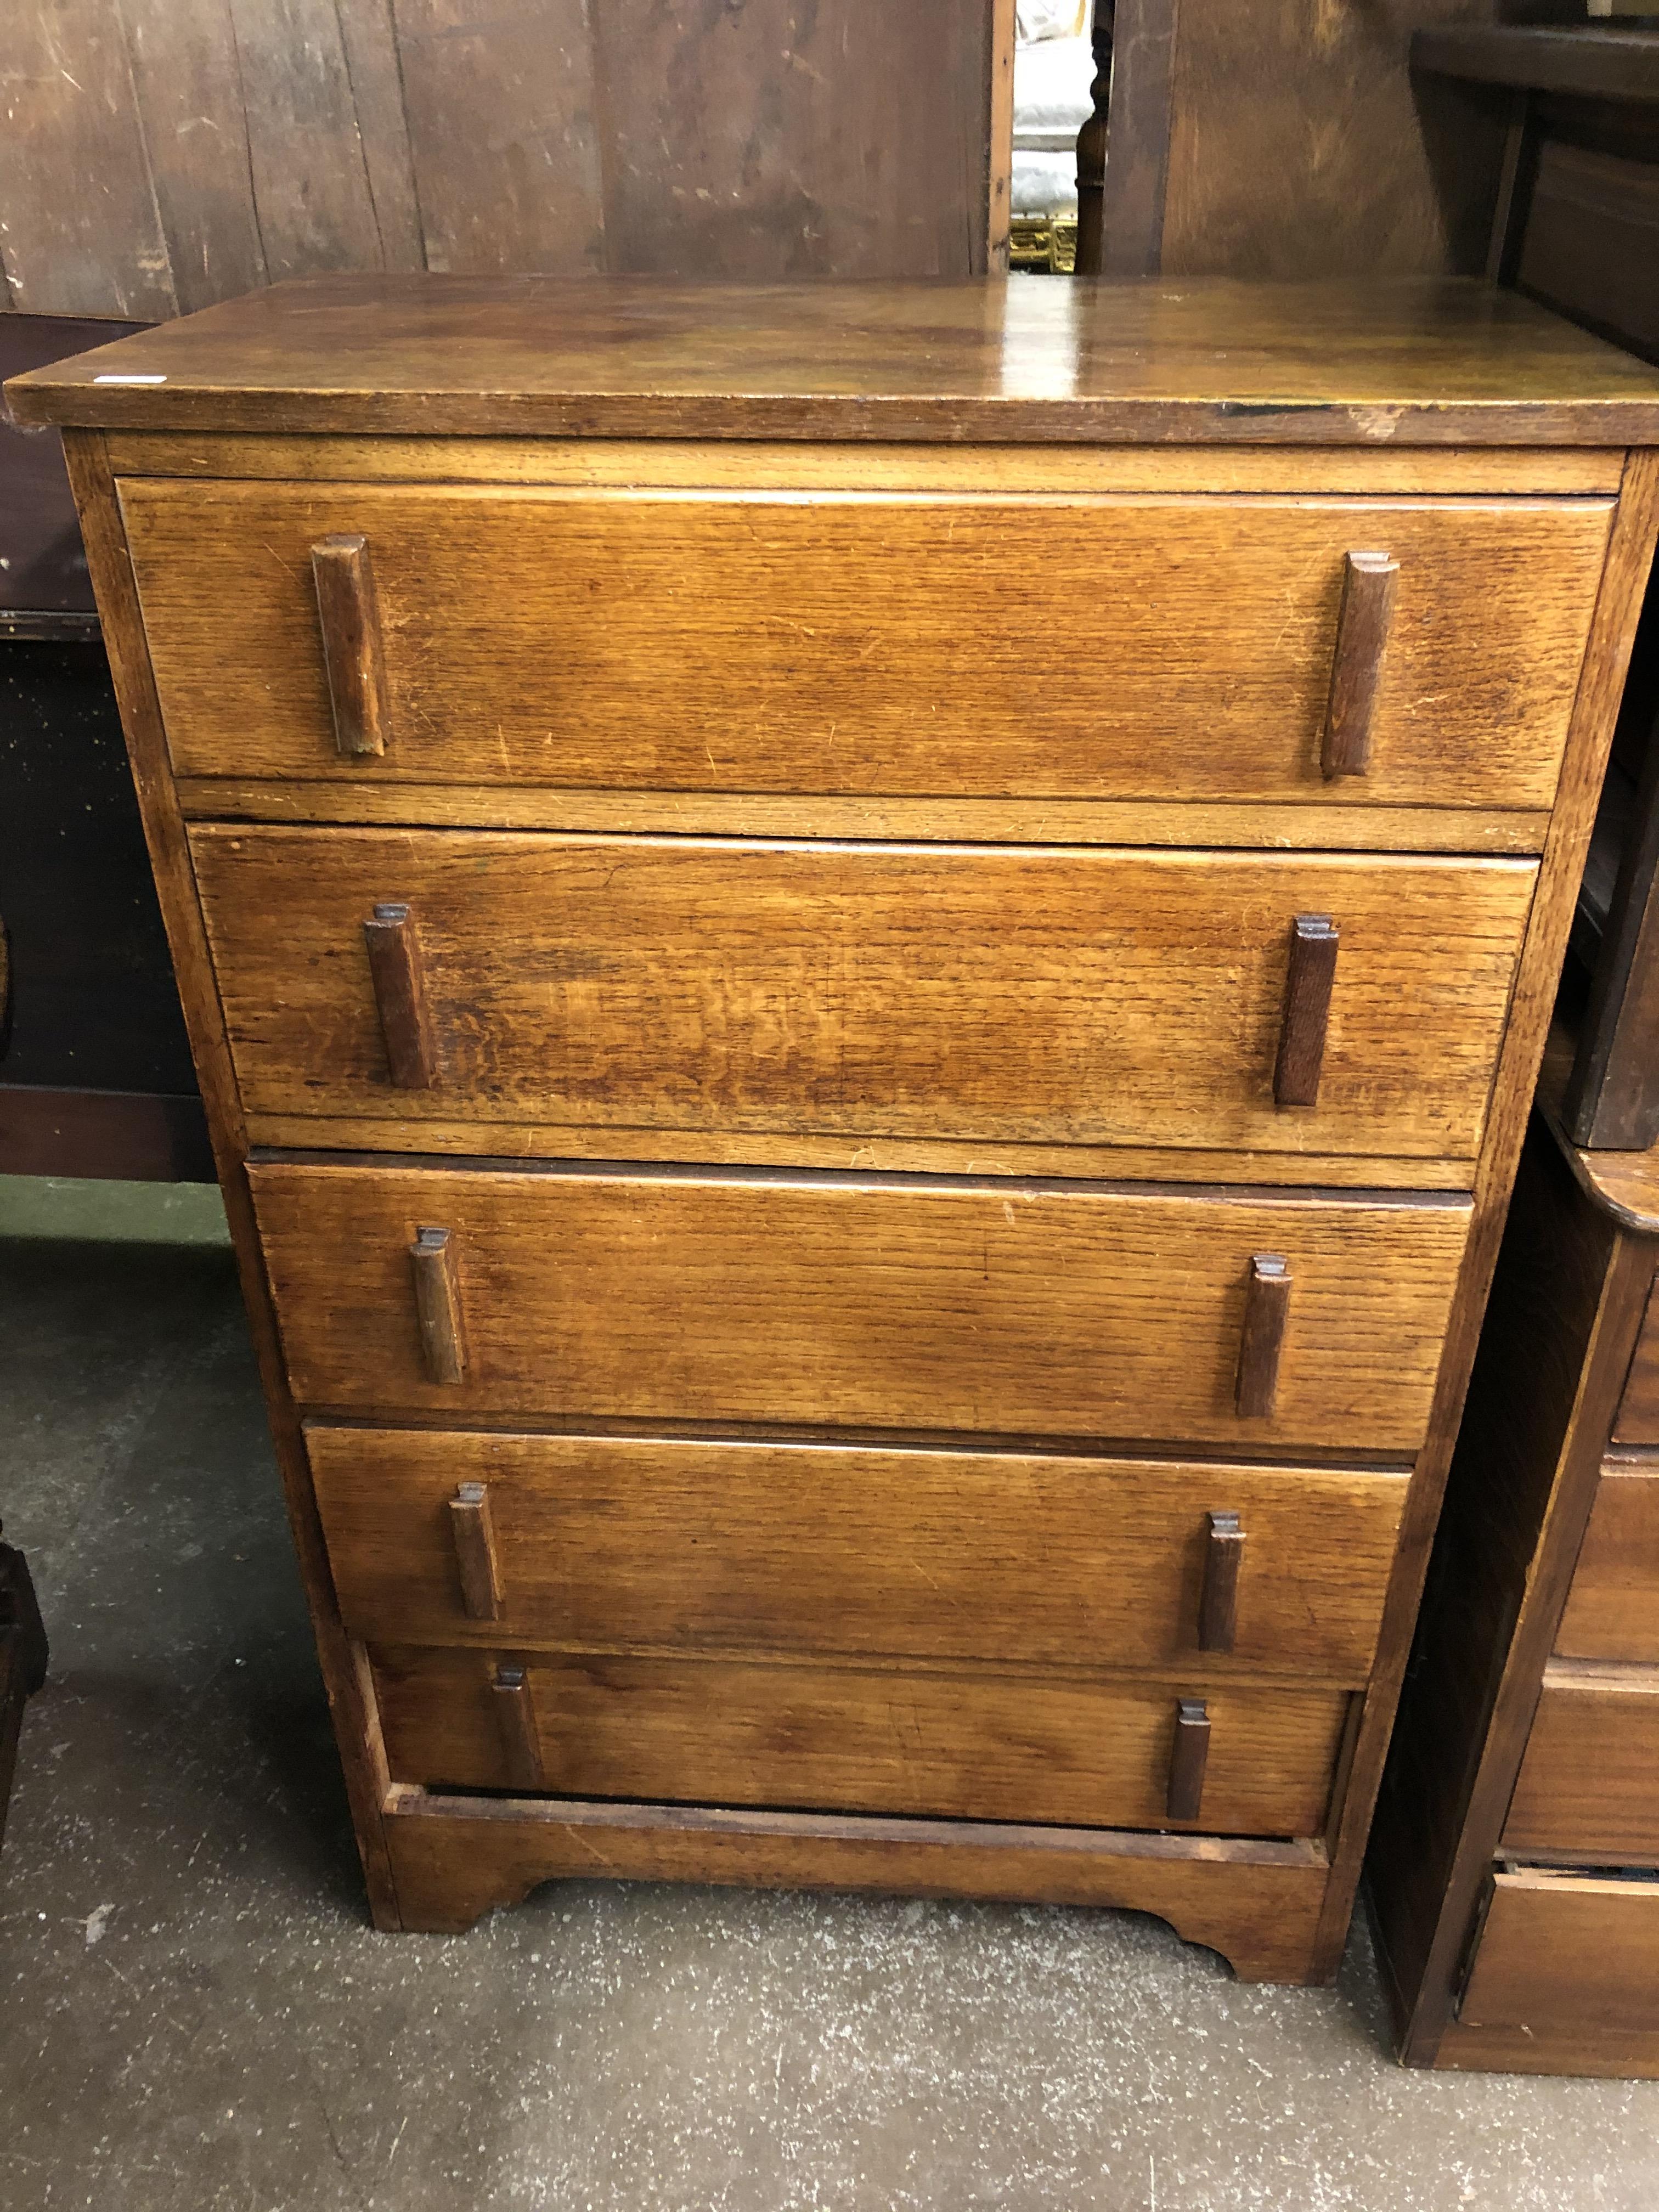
[0,0,179,323]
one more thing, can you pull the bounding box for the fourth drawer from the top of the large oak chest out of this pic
[307,1427,1407,1688]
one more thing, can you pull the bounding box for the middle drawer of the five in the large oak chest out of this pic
[250,1164,1469,1455]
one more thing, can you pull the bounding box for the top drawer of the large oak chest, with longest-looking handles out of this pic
[122,480,1612,808]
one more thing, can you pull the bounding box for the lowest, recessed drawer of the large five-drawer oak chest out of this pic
[371,1646,1350,1836]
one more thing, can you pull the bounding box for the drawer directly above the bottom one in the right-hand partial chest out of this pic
[1504,1666,1659,1865]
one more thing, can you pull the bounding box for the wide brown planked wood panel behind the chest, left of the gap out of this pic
[0,0,1013,321]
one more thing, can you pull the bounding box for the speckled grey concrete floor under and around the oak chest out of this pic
[0,1183,1659,2212]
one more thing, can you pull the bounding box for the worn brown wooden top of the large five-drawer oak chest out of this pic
[19,274,1659,447]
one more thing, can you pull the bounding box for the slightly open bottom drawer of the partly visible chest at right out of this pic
[1458,1867,1659,2042]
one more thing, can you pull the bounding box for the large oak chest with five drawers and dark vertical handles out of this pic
[11,279,1659,1980]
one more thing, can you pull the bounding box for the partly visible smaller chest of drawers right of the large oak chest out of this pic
[1369,1088,1659,2075]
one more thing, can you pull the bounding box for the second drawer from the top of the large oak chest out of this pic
[190,827,1537,1161]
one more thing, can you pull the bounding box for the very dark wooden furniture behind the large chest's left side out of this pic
[0,314,212,1181]
